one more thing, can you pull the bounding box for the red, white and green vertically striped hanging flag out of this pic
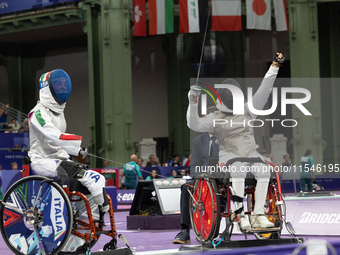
[149,0,174,35]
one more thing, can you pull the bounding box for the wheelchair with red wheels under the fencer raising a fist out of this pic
[189,158,284,246]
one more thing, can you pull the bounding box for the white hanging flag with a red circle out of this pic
[246,0,272,30]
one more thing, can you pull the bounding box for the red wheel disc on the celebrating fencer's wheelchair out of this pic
[191,179,216,241]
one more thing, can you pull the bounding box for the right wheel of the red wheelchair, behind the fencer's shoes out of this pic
[247,187,282,239]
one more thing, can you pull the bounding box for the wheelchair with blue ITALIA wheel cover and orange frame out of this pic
[0,162,127,255]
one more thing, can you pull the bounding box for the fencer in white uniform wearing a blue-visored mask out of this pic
[28,69,109,212]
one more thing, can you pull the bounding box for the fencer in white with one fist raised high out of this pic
[187,54,284,229]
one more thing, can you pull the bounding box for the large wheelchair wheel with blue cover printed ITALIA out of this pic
[0,176,73,255]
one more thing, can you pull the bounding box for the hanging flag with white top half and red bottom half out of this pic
[212,0,242,31]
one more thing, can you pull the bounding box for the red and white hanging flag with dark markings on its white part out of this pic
[179,0,200,33]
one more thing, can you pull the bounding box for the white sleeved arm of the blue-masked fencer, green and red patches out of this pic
[29,109,82,155]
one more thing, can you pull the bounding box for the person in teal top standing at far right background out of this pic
[300,149,315,192]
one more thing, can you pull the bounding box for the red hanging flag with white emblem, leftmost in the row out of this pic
[133,0,146,36]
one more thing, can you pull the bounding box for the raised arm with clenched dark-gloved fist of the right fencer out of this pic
[246,53,284,119]
